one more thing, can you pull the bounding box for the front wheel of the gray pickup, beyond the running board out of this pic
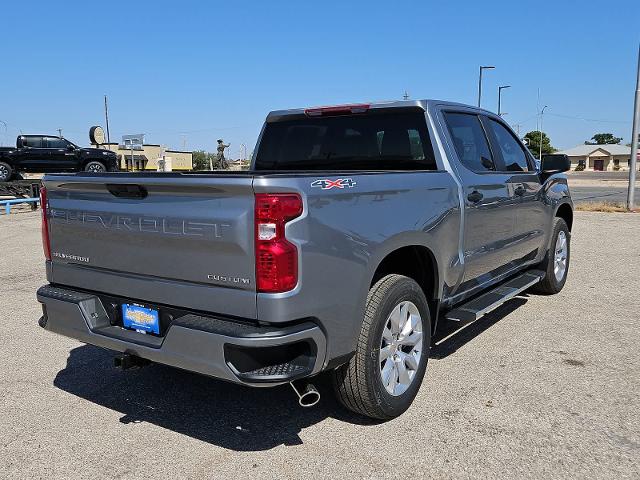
[531,217,571,295]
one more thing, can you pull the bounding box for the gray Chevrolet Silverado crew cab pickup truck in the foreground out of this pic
[37,100,573,419]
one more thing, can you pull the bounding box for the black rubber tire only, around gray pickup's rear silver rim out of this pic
[331,274,431,420]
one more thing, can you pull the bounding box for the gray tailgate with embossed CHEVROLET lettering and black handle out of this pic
[44,174,256,318]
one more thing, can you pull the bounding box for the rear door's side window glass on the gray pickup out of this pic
[444,112,495,172]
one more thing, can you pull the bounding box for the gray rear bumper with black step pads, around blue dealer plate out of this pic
[37,285,326,386]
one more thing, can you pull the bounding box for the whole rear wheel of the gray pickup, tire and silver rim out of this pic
[332,274,431,420]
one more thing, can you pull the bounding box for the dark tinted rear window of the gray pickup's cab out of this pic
[254,109,436,170]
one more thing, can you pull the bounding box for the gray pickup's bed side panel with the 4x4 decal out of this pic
[254,171,460,359]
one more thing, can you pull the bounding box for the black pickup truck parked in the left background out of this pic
[0,135,118,182]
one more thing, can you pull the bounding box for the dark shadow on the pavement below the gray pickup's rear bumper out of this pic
[53,345,376,451]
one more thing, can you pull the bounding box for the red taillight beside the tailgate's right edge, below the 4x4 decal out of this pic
[255,193,302,293]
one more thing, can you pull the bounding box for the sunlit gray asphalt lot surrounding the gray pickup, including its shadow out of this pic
[0,212,640,479]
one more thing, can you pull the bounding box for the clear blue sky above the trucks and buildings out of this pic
[0,0,640,158]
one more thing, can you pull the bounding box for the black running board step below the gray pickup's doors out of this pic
[445,270,545,323]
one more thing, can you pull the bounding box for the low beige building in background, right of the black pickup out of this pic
[92,143,193,171]
